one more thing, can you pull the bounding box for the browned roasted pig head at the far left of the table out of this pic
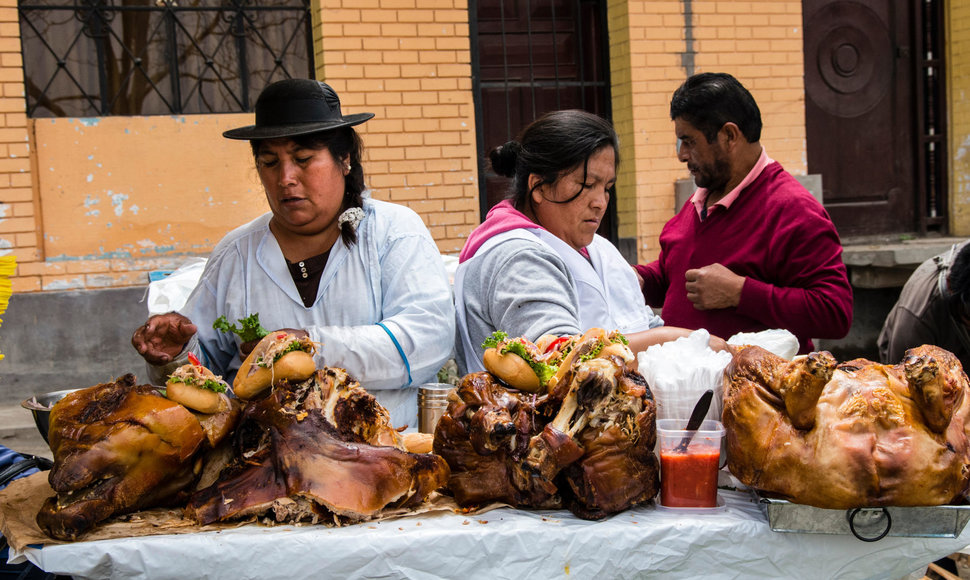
[37,374,206,540]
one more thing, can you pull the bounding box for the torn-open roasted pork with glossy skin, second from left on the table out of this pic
[186,367,448,524]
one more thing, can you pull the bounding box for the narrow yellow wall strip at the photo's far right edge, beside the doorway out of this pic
[946,2,970,237]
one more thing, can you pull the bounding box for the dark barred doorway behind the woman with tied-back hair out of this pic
[469,0,616,242]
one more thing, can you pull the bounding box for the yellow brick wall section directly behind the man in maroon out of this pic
[610,0,806,261]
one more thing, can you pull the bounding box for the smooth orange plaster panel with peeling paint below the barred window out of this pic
[34,115,268,262]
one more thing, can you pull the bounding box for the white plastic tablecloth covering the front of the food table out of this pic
[11,490,970,580]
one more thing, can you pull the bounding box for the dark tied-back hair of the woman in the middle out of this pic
[488,109,620,210]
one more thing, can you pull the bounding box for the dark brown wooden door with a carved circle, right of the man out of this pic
[800,0,922,237]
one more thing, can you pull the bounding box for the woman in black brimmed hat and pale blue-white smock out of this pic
[132,79,455,426]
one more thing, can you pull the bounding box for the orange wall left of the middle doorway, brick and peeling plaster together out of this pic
[0,0,478,292]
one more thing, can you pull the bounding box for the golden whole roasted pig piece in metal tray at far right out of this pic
[722,345,970,509]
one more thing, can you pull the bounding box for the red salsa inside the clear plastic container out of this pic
[660,449,721,507]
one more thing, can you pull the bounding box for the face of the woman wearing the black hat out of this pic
[256,139,349,235]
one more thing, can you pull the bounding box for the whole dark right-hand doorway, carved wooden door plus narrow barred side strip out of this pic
[802,0,946,237]
